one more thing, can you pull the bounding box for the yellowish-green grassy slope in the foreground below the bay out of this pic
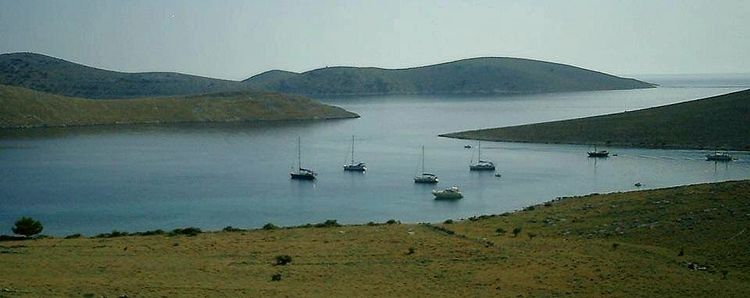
[0,181,750,297]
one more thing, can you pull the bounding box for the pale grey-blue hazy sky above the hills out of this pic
[0,0,750,80]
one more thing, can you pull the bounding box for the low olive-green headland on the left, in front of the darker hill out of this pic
[0,85,358,128]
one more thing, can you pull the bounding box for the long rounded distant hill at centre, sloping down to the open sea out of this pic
[244,58,654,97]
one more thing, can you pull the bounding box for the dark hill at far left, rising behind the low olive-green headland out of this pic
[0,53,247,99]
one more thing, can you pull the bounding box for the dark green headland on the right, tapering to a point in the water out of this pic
[441,90,750,151]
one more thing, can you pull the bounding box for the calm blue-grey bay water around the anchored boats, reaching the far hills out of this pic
[0,86,750,235]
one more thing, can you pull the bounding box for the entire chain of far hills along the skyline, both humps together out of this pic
[0,53,655,99]
